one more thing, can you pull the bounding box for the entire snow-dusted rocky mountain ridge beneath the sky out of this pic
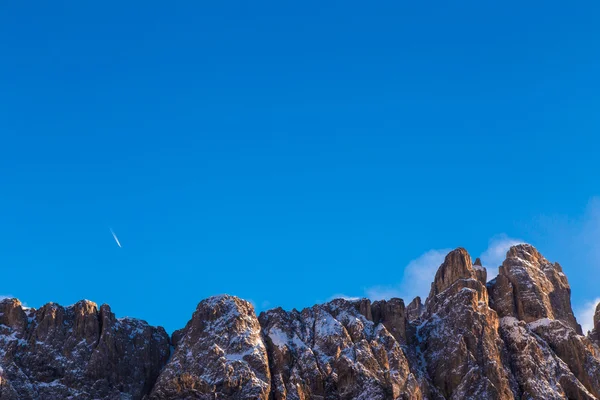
[0,244,600,400]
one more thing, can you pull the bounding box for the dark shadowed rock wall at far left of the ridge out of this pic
[0,299,169,399]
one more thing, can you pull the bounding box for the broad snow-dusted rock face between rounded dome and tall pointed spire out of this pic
[259,299,423,400]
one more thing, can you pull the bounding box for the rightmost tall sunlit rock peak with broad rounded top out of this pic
[488,244,600,400]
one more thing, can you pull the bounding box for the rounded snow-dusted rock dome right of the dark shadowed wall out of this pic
[150,296,271,400]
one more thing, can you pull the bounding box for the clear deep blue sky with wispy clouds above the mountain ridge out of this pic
[0,1,600,331]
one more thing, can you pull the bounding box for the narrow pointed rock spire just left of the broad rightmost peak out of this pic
[417,248,513,399]
